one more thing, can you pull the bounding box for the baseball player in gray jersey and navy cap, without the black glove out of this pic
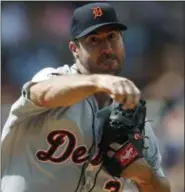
[1,3,170,192]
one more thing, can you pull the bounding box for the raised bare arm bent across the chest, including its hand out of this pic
[30,74,140,108]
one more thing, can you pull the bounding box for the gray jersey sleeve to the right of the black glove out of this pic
[144,122,165,177]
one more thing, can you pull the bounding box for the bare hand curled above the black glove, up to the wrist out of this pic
[98,75,141,109]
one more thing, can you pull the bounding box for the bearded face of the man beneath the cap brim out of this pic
[74,27,125,75]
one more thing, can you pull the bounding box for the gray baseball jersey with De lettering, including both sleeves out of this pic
[1,64,164,192]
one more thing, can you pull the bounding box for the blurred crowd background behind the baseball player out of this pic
[1,1,184,192]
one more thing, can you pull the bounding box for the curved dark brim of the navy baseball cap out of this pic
[75,22,127,39]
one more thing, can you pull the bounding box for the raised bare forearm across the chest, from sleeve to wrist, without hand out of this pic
[30,75,101,108]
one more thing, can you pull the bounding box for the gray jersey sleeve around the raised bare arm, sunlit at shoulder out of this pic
[4,66,70,129]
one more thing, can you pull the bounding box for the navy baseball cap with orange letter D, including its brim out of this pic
[71,3,127,40]
